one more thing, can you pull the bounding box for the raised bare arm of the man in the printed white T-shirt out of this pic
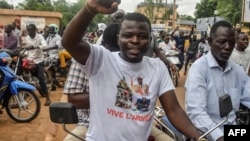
[62,0,120,64]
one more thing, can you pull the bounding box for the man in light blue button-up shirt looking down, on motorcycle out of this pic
[185,20,250,141]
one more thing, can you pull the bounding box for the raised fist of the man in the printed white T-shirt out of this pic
[85,0,121,14]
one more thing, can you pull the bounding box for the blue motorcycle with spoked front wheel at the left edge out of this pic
[0,52,41,123]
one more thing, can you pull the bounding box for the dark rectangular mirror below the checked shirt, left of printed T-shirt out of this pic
[49,102,78,124]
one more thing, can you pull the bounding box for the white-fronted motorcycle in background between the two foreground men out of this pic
[165,50,181,87]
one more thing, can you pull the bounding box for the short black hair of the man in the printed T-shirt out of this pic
[119,12,151,31]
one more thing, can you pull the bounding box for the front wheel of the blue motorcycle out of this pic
[5,89,41,123]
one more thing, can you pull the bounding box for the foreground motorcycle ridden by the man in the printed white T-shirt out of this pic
[49,94,233,141]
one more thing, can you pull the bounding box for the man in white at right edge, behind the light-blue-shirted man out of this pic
[230,32,250,76]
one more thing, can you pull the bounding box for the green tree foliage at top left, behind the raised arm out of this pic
[5,0,108,31]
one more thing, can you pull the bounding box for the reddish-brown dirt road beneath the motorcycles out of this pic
[0,72,186,141]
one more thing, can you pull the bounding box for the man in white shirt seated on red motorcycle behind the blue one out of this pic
[25,24,51,106]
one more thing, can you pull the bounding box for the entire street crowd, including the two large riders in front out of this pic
[0,0,250,141]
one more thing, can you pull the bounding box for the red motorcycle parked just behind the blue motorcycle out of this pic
[14,47,53,97]
